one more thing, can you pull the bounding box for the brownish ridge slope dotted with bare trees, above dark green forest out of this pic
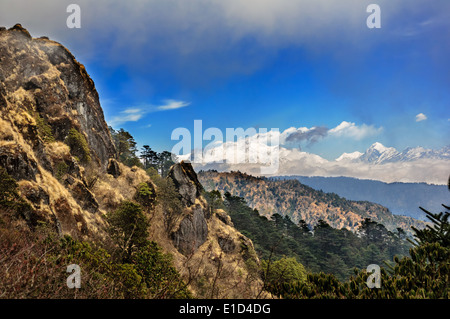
[199,171,423,232]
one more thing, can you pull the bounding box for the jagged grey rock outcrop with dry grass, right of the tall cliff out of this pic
[164,162,261,297]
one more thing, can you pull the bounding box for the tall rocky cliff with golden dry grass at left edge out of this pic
[0,24,120,236]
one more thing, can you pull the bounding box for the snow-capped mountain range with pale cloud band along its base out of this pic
[193,142,450,185]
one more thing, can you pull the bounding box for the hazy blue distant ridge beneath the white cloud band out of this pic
[278,175,450,220]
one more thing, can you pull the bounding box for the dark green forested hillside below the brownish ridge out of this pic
[206,191,410,281]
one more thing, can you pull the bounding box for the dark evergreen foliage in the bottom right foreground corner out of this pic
[278,205,450,299]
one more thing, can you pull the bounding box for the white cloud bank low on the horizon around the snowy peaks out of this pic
[178,121,449,184]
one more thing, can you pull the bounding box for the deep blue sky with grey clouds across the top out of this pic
[0,0,450,159]
